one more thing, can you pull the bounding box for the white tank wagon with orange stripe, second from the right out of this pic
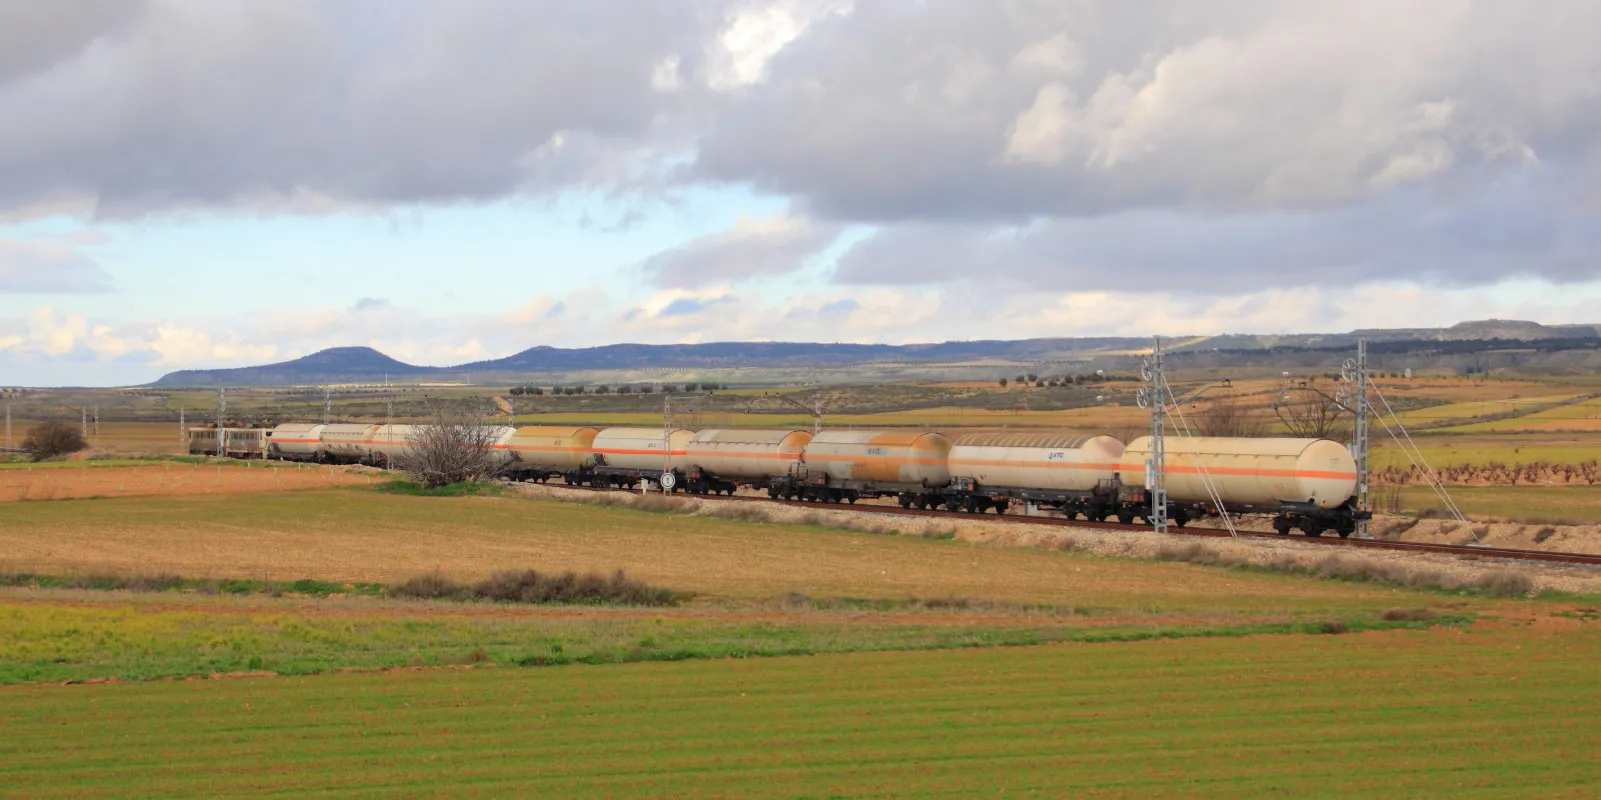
[946,432,1124,520]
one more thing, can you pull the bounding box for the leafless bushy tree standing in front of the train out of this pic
[394,400,504,490]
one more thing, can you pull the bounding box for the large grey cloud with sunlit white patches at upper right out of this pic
[693,0,1601,222]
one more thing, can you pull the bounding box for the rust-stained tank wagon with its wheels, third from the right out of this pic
[787,430,951,509]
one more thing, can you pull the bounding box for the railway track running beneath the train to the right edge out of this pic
[509,482,1601,566]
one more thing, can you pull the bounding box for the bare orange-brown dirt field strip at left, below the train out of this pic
[0,461,378,502]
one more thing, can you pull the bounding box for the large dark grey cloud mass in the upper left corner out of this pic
[0,0,722,216]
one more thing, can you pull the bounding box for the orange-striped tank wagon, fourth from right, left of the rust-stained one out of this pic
[684,429,812,494]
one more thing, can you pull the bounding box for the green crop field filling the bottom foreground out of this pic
[0,624,1601,800]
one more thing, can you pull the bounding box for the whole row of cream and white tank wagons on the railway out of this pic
[192,422,1369,536]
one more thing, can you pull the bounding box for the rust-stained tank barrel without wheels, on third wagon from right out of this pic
[805,430,951,488]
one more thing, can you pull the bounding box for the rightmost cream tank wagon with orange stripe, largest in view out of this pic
[1117,437,1369,536]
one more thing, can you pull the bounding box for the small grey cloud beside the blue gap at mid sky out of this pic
[639,214,842,288]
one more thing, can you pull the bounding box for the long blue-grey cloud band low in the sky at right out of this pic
[834,168,1601,294]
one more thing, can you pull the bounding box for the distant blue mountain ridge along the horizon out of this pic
[152,320,1601,386]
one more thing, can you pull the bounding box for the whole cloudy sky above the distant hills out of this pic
[0,0,1601,386]
